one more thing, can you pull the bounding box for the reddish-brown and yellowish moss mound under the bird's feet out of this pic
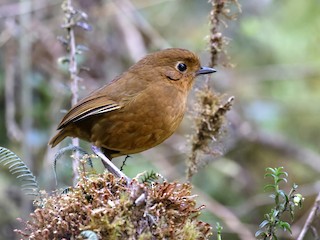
[16,173,211,240]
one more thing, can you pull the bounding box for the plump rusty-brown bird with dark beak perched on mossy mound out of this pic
[49,48,215,159]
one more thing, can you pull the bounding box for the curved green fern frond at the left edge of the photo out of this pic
[0,147,40,196]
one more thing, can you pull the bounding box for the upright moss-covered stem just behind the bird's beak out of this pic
[187,0,240,180]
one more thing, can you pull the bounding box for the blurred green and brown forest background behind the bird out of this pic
[0,0,320,239]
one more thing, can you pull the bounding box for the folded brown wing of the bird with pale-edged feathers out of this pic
[58,95,121,129]
